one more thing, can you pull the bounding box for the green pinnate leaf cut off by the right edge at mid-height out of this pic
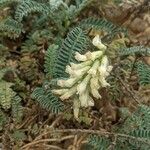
[137,62,150,85]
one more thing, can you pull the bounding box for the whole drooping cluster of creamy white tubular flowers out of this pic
[52,35,112,118]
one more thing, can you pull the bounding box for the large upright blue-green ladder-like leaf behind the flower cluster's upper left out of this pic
[53,27,89,78]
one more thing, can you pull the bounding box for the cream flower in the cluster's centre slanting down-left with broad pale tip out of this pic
[77,74,91,94]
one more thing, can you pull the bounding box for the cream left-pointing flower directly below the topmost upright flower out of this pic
[85,51,104,61]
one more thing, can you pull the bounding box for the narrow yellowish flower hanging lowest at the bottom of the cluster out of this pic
[73,98,80,119]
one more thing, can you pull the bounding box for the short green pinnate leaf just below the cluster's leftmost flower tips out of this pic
[32,85,63,113]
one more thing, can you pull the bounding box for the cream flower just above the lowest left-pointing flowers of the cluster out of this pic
[57,78,78,87]
